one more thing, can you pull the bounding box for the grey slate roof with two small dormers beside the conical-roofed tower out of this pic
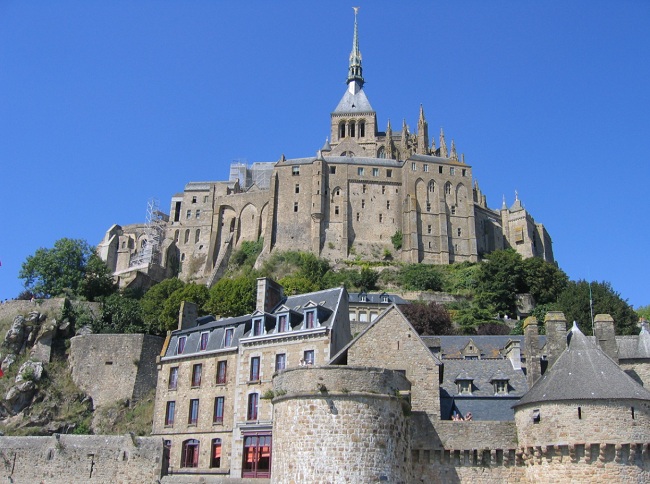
[440,359,528,421]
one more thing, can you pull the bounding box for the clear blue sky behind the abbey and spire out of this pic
[0,0,650,307]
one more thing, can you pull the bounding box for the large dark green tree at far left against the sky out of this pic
[18,238,112,297]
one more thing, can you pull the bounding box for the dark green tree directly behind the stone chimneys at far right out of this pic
[557,280,638,335]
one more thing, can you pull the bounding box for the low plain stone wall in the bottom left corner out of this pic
[0,434,166,484]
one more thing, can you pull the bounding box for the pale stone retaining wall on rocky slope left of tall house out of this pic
[69,334,164,407]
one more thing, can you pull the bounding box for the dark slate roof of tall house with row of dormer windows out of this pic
[164,288,345,358]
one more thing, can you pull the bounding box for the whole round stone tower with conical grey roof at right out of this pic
[514,323,650,482]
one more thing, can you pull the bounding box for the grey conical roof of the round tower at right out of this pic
[515,323,650,407]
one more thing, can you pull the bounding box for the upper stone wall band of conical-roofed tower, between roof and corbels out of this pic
[515,400,650,448]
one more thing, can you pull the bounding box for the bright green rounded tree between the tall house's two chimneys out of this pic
[205,276,257,317]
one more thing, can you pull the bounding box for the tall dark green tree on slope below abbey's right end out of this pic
[474,249,527,317]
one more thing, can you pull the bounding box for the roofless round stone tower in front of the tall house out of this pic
[271,367,412,483]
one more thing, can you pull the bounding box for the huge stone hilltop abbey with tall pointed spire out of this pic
[99,12,553,292]
